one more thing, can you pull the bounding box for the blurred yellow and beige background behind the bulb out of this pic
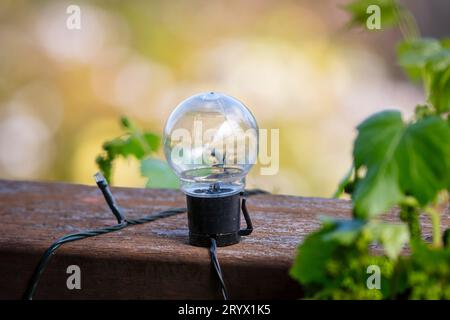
[0,0,450,196]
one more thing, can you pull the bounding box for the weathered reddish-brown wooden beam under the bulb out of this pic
[0,180,450,299]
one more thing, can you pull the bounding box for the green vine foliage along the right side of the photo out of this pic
[290,0,450,299]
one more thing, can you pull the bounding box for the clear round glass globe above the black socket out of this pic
[164,92,258,197]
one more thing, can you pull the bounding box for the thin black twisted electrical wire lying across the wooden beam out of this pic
[23,173,267,300]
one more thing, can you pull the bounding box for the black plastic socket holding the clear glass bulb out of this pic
[186,193,253,247]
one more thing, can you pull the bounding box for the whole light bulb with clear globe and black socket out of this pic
[163,92,258,247]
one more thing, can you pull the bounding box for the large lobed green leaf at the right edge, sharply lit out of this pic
[353,111,450,218]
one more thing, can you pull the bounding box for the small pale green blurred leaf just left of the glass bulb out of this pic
[141,158,179,189]
